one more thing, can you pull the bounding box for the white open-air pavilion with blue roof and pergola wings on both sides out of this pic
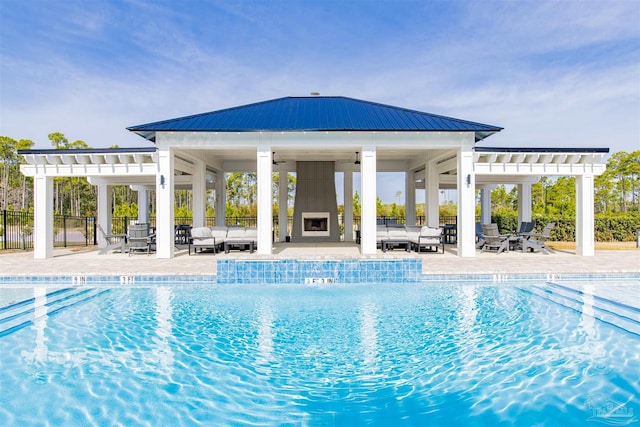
[20,96,609,258]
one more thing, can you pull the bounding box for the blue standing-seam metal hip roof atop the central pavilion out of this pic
[127,96,502,141]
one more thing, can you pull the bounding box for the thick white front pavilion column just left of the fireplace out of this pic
[257,144,273,255]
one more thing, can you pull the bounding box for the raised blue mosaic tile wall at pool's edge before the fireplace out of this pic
[217,259,422,284]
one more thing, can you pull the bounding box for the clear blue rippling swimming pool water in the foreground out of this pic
[0,283,640,426]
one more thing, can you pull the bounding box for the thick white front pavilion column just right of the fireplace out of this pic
[360,145,376,255]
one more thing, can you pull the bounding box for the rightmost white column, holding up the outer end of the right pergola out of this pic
[576,175,595,256]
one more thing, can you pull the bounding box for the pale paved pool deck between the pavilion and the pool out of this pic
[0,243,640,276]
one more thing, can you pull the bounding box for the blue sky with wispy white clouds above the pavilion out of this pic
[0,0,640,203]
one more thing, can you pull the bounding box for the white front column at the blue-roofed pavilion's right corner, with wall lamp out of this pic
[457,141,476,258]
